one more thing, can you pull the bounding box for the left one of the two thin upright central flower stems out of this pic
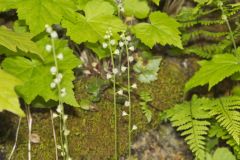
[109,42,118,160]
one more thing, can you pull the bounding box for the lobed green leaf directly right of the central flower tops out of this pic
[132,12,182,48]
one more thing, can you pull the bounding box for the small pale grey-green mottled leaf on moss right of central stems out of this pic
[133,58,162,83]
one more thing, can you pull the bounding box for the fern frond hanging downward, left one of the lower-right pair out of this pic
[166,97,210,159]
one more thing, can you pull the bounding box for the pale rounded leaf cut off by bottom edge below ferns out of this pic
[206,147,236,160]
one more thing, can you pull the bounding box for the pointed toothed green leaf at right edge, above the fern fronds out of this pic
[185,54,240,91]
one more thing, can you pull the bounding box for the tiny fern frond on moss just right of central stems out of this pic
[140,92,153,123]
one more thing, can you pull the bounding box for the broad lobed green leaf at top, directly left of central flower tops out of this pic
[63,0,125,43]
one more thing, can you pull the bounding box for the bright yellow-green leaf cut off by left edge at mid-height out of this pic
[0,69,25,116]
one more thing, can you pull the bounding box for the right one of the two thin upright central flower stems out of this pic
[125,44,132,157]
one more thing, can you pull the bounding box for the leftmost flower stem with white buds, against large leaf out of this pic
[51,38,70,160]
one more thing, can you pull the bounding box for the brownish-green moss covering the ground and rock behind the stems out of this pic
[2,59,188,160]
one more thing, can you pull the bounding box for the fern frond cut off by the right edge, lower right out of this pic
[208,96,240,145]
